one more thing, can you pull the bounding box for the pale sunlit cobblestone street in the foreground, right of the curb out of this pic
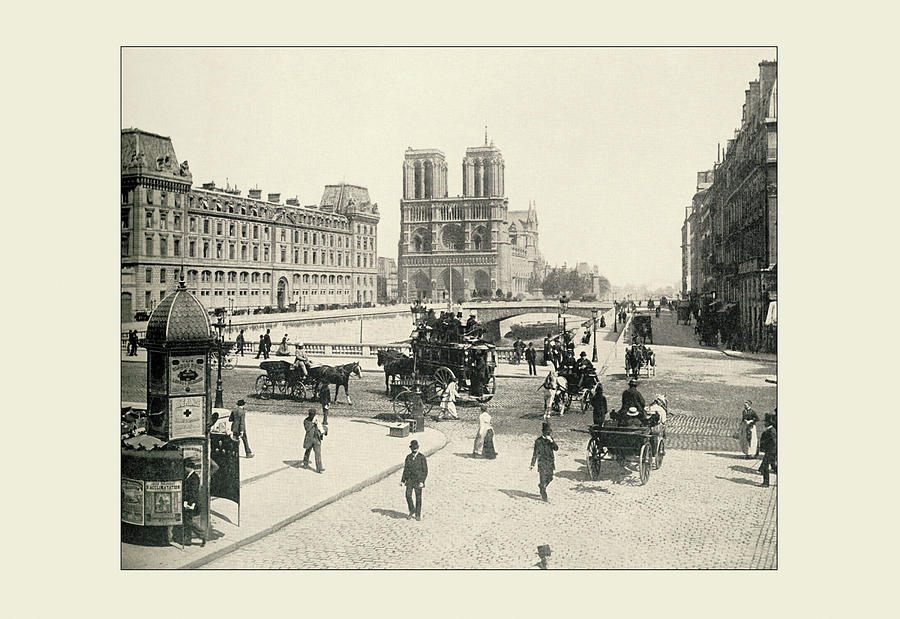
[207,422,777,568]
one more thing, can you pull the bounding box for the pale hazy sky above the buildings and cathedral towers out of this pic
[122,48,776,288]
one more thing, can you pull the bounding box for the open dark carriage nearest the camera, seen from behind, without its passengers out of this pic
[587,422,665,486]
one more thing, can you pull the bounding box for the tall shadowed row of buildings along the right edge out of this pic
[682,61,778,350]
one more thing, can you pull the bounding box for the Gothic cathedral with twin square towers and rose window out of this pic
[398,135,541,301]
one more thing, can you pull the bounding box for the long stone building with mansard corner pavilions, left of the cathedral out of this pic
[121,129,379,320]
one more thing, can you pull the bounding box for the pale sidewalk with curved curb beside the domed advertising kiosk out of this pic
[121,414,447,569]
